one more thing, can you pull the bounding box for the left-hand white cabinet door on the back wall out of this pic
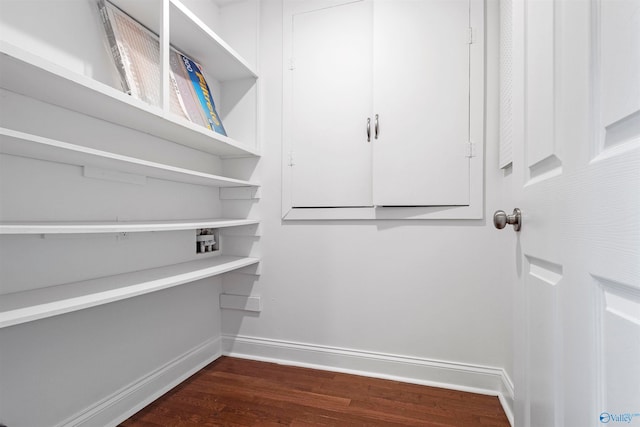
[290,1,372,207]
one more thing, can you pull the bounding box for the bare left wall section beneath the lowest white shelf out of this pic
[0,280,220,427]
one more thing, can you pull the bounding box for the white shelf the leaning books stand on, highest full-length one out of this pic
[0,41,259,157]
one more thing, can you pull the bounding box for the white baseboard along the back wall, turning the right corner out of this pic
[222,335,513,425]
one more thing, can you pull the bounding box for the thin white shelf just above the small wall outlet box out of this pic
[0,219,259,234]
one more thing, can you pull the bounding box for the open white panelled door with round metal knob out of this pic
[510,0,640,427]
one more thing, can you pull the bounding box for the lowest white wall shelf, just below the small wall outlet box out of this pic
[0,256,259,328]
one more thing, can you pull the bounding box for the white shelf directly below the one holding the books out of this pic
[0,128,258,187]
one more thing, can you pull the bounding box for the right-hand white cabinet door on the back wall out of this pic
[373,0,470,206]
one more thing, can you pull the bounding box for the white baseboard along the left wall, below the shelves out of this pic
[57,337,222,427]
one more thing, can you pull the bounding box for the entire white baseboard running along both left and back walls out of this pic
[52,336,513,427]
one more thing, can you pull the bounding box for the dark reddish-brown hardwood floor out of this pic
[121,357,509,427]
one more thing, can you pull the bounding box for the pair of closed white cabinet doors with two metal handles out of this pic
[285,0,471,207]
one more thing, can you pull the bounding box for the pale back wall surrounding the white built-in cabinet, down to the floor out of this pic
[223,0,513,402]
